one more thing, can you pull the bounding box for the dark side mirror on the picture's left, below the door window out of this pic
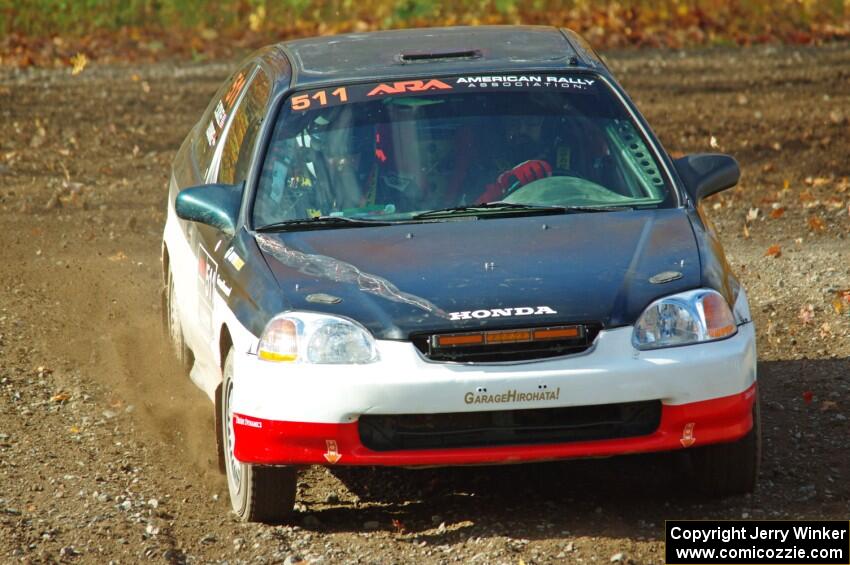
[174,184,242,236]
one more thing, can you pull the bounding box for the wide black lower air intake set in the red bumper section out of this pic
[358,400,661,451]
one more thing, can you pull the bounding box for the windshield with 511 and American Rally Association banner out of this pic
[248,74,676,227]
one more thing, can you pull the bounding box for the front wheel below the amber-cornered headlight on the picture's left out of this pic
[221,347,298,524]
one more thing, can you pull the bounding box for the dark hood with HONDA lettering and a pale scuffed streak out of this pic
[256,209,701,339]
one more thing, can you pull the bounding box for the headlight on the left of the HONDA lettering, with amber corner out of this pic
[257,312,378,364]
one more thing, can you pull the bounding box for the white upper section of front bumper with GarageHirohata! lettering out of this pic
[233,323,756,423]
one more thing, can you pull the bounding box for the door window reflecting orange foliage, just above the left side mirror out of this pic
[218,69,271,184]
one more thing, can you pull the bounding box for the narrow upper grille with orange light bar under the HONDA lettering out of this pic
[411,323,601,363]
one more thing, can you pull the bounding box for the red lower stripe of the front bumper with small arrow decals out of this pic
[233,384,756,466]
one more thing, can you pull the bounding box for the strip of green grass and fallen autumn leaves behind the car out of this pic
[0,0,850,66]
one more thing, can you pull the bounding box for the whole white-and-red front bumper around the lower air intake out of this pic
[233,324,756,466]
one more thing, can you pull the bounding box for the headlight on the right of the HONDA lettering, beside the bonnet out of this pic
[632,289,738,349]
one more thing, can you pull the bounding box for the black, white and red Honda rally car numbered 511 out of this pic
[162,27,760,521]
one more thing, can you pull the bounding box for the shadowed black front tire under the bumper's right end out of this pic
[688,390,762,497]
